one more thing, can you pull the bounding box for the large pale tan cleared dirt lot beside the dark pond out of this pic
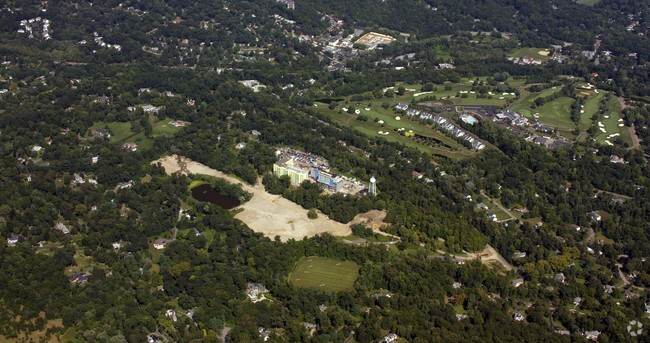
[152,155,352,241]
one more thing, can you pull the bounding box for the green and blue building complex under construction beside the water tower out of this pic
[273,148,365,194]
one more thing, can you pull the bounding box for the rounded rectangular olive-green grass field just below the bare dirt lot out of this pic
[289,256,359,292]
